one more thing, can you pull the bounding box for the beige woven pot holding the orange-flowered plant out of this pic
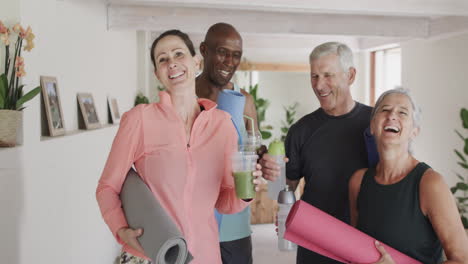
[0,110,23,147]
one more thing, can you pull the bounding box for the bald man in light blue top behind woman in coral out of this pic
[196,23,280,264]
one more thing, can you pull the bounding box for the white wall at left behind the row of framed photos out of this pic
[0,0,137,264]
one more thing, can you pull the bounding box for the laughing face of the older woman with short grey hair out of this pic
[371,93,419,146]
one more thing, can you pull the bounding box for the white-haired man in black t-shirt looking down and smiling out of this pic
[286,42,372,264]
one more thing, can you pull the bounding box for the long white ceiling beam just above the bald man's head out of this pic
[108,5,429,38]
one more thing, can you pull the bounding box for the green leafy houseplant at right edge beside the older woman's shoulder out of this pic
[450,108,468,229]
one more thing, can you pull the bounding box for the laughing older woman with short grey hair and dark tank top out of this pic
[349,89,468,264]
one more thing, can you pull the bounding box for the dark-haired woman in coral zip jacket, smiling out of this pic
[96,30,261,264]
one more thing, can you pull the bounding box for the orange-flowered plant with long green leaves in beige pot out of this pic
[0,21,41,147]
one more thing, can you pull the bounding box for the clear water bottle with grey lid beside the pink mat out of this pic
[278,185,297,251]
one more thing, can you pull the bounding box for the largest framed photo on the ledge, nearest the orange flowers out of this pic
[41,76,65,137]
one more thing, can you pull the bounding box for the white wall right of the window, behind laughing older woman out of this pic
[401,34,468,185]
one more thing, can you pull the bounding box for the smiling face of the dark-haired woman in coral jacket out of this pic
[154,35,199,94]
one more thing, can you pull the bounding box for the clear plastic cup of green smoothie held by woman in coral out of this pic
[232,151,258,199]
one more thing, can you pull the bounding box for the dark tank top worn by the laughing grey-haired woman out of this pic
[357,162,442,264]
